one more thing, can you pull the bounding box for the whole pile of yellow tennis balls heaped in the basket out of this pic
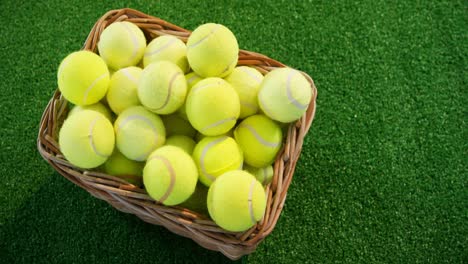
[57,22,311,232]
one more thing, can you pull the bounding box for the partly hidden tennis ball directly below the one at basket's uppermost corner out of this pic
[106,66,143,114]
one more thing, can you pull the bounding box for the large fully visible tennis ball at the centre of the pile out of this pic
[185,77,240,136]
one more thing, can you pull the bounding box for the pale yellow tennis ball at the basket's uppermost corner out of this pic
[97,21,146,70]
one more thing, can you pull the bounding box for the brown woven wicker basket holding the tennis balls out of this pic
[37,9,317,260]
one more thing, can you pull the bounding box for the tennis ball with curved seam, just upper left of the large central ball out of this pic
[138,61,187,115]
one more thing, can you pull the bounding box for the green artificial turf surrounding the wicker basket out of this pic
[0,0,468,263]
